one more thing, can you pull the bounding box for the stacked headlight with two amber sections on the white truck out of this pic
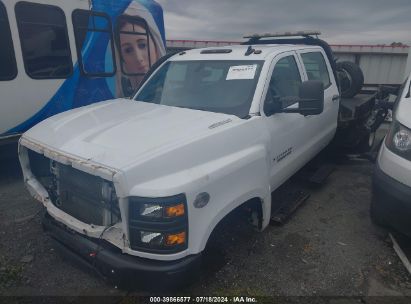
[129,194,188,253]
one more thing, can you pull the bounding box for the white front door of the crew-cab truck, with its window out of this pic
[261,52,316,191]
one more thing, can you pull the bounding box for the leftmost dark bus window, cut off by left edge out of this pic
[0,2,17,80]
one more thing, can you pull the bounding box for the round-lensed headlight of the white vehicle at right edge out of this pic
[385,120,411,160]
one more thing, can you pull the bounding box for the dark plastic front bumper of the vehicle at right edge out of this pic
[372,163,411,237]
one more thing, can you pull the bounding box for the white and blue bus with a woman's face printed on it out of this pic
[0,0,165,144]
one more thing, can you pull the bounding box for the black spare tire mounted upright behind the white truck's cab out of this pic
[337,61,364,98]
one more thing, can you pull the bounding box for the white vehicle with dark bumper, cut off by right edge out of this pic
[371,76,411,237]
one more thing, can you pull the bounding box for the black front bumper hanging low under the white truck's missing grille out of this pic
[43,213,201,290]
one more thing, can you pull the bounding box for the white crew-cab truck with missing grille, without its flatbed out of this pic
[19,33,388,284]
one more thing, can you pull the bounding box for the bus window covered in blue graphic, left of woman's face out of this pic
[72,9,116,77]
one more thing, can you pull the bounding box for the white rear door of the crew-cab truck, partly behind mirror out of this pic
[298,49,340,149]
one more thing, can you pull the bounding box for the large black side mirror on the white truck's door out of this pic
[298,80,324,116]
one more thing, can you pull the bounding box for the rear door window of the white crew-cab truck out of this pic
[301,52,331,89]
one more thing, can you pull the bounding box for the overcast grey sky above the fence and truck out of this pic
[157,0,411,45]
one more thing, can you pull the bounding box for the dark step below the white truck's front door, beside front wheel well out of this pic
[270,190,310,225]
